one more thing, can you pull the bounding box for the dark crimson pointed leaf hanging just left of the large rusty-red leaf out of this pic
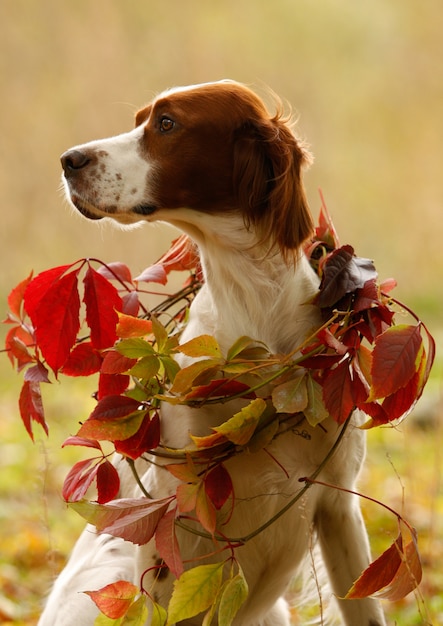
[323,360,355,424]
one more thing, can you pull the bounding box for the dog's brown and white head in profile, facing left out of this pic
[61,81,312,255]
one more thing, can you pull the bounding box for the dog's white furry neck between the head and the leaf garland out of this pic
[166,214,320,353]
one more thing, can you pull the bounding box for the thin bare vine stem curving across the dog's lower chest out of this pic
[175,417,352,545]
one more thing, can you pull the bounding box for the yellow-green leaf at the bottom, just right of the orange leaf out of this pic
[167,563,224,626]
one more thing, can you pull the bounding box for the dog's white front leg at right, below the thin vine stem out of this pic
[316,491,386,626]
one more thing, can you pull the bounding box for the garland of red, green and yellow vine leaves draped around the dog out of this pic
[1,206,435,625]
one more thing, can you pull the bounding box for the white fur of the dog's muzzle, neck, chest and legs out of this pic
[39,87,385,626]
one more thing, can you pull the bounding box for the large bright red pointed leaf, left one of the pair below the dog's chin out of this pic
[25,266,80,373]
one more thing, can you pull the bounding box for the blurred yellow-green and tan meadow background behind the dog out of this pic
[0,0,443,625]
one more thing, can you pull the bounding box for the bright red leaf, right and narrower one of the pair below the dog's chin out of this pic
[83,267,122,350]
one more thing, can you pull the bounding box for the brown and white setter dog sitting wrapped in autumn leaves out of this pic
[39,80,385,626]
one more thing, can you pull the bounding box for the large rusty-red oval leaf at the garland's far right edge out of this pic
[371,324,423,399]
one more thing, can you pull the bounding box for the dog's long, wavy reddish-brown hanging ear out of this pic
[234,116,313,260]
